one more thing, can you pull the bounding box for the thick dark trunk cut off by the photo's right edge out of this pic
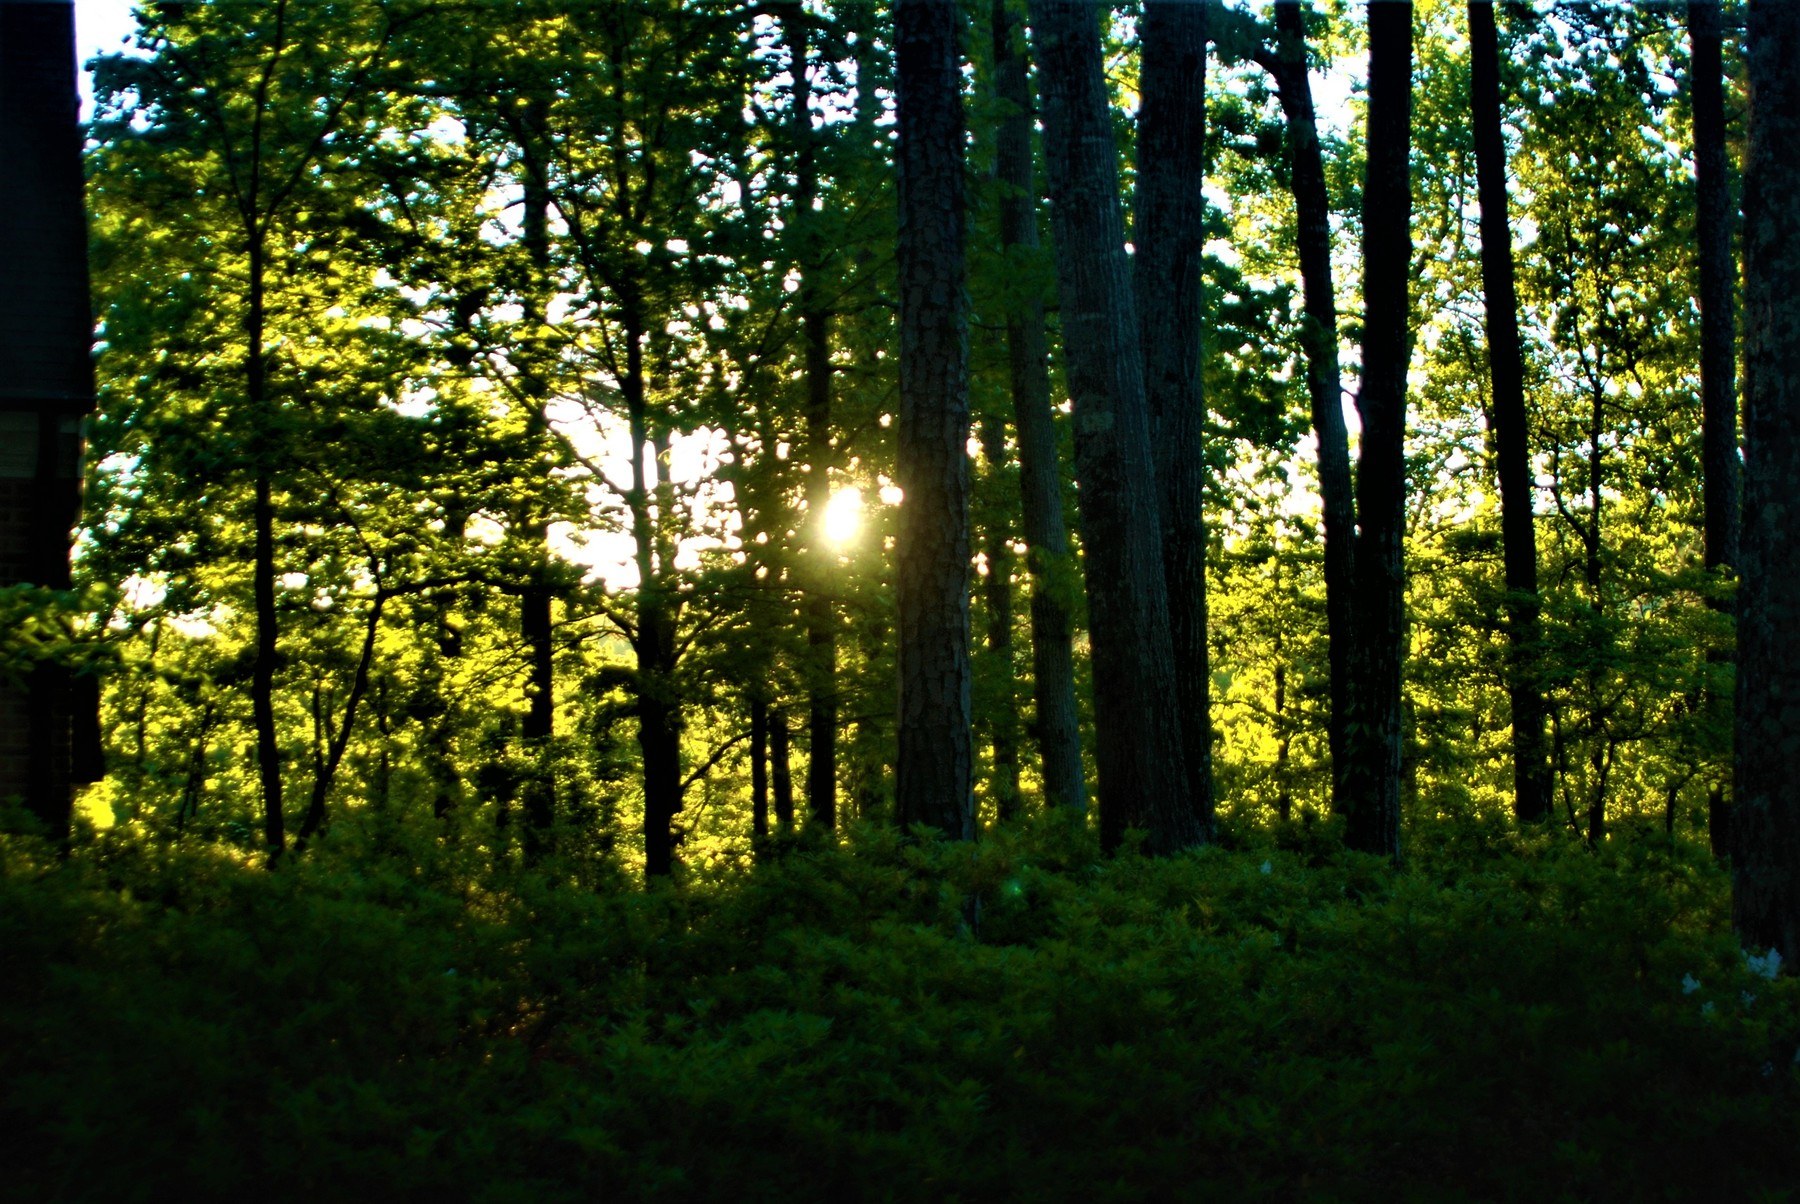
[1732,0,1800,966]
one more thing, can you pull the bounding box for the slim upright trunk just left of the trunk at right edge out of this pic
[1688,0,1737,857]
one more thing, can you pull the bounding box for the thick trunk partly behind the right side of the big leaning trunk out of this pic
[1132,0,1213,839]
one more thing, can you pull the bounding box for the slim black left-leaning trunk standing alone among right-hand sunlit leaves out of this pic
[1469,0,1550,822]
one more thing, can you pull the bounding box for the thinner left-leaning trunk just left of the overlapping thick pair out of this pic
[992,0,1087,810]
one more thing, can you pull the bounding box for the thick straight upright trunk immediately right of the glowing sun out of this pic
[895,0,974,840]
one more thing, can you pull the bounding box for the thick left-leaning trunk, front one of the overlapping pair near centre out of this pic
[1031,0,1206,853]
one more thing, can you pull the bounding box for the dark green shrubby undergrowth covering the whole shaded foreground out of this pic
[0,806,1800,1202]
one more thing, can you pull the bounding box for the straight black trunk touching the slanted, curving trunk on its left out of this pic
[1345,0,1413,857]
